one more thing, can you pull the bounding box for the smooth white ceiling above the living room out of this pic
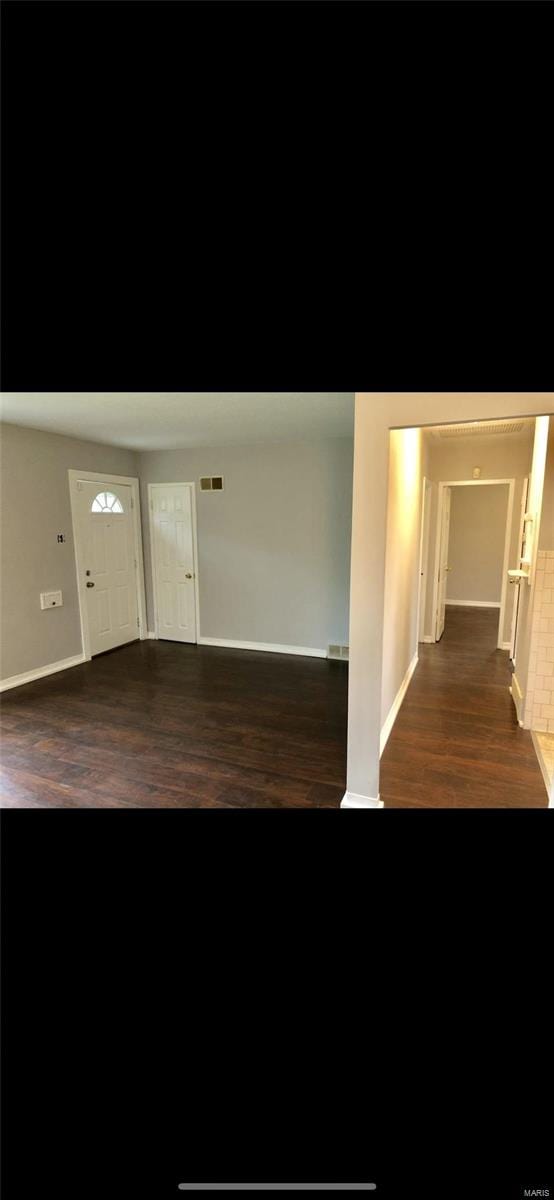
[0,391,354,450]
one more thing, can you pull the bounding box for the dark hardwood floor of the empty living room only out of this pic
[1,641,348,809]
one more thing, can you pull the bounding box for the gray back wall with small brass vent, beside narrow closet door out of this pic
[139,438,353,649]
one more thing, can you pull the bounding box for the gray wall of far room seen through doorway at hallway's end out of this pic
[446,484,508,604]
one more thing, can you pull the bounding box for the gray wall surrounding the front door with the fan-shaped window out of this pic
[0,424,137,679]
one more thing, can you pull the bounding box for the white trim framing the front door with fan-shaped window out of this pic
[67,469,147,662]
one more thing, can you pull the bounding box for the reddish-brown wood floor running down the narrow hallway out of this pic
[380,606,548,809]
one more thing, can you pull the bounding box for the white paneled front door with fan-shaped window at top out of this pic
[77,479,139,654]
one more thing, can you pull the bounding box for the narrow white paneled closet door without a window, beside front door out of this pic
[150,484,197,642]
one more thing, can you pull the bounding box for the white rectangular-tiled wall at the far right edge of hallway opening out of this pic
[524,550,554,733]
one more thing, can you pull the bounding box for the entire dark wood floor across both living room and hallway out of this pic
[1,608,548,809]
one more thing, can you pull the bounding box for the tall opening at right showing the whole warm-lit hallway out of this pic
[380,418,554,808]
